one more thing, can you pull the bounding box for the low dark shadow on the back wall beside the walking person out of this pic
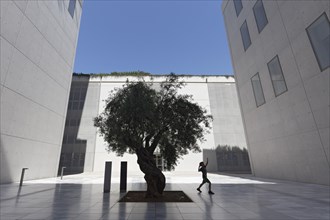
[203,145,251,173]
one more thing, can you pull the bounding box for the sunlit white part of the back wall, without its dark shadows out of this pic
[73,76,246,175]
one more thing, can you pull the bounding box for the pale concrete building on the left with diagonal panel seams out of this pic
[0,0,82,183]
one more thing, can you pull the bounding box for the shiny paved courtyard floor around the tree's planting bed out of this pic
[0,173,330,220]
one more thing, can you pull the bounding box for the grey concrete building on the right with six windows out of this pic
[222,0,330,185]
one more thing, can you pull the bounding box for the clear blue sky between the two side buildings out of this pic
[74,0,233,75]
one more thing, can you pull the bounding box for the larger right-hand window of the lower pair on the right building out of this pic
[267,56,288,96]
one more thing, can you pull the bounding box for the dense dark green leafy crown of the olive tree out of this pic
[94,74,212,169]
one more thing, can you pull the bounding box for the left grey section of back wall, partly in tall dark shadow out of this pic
[58,75,100,174]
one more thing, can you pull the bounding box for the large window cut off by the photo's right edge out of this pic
[306,13,330,71]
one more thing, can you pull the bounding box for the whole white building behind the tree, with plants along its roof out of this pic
[59,75,246,174]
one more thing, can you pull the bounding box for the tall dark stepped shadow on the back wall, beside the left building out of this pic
[58,76,89,175]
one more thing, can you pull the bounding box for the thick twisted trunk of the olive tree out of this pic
[136,147,165,197]
